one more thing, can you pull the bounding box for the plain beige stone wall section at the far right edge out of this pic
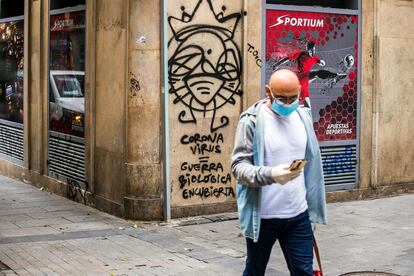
[374,0,414,185]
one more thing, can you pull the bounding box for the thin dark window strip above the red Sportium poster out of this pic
[266,0,358,10]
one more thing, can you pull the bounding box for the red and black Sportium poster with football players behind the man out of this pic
[265,9,358,142]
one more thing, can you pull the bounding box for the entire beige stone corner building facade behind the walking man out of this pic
[0,0,414,220]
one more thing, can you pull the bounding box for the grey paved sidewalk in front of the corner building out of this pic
[0,176,414,276]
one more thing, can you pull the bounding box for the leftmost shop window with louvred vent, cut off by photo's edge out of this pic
[0,0,24,161]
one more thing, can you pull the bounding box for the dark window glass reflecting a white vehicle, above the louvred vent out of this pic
[49,4,85,138]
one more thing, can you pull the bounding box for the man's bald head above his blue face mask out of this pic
[266,69,300,97]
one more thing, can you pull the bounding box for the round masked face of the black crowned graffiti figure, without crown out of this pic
[169,28,241,106]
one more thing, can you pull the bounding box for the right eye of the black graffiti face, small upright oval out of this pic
[217,49,241,81]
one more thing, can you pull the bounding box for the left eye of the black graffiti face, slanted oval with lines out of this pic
[168,45,204,77]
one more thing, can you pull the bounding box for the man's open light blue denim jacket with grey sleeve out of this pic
[231,100,327,242]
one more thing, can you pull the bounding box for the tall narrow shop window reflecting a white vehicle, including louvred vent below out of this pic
[48,0,87,189]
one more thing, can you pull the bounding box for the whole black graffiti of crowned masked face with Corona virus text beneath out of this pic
[168,0,244,200]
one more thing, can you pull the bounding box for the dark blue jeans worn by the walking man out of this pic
[243,211,313,276]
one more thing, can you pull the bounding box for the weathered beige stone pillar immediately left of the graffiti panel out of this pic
[124,0,164,219]
